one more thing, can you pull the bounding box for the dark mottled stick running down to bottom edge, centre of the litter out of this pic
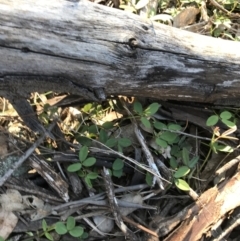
[102,167,138,241]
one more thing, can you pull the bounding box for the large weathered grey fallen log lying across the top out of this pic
[0,0,240,104]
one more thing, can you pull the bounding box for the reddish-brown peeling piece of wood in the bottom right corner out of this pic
[153,158,240,241]
